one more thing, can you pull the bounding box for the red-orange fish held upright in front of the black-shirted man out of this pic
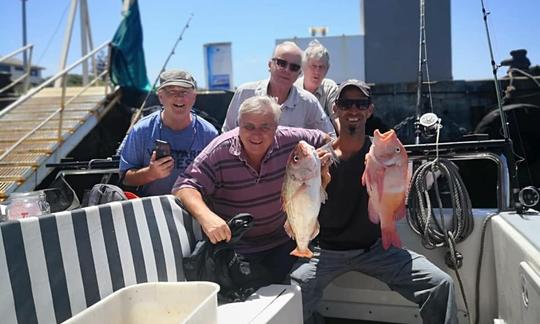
[362,129,410,249]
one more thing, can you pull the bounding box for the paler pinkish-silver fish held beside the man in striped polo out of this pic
[281,141,330,258]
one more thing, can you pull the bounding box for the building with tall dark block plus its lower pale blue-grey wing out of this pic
[276,0,453,83]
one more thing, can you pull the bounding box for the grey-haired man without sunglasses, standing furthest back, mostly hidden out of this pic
[294,40,339,133]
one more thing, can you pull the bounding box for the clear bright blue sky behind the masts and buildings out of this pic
[0,0,540,86]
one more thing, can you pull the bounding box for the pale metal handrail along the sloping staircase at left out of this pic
[0,41,110,161]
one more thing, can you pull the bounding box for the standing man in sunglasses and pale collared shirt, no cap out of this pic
[222,42,335,136]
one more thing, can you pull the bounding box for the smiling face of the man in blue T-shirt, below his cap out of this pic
[158,85,197,120]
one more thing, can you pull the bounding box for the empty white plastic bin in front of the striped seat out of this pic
[64,282,219,324]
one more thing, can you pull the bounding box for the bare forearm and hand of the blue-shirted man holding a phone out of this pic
[124,152,174,186]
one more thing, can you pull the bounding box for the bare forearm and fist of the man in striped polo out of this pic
[175,188,231,244]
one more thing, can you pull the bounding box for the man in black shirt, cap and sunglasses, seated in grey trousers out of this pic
[290,80,458,324]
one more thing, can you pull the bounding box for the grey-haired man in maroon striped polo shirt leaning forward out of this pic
[173,96,330,283]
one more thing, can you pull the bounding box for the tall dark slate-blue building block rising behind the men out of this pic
[362,0,452,83]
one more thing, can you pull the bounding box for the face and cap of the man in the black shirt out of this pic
[334,86,373,135]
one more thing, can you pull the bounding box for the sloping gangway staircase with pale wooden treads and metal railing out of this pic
[0,43,120,201]
